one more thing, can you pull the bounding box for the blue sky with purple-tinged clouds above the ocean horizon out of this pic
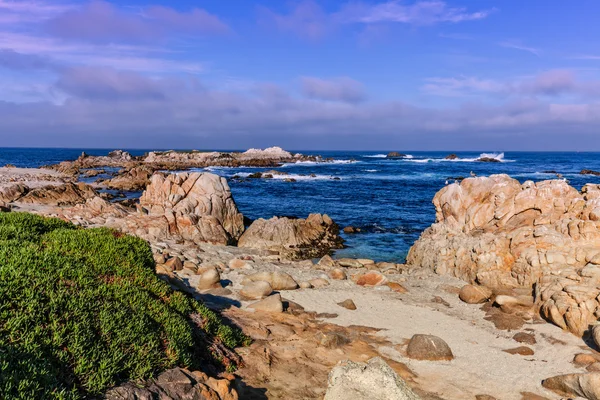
[0,0,600,151]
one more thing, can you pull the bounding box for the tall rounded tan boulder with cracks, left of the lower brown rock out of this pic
[138,172,244,244]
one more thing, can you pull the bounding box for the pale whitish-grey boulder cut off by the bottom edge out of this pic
[324,357,419,400]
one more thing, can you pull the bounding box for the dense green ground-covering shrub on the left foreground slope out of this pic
[0,213,246,399]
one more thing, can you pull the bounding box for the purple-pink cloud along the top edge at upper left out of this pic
[46,0,229,43]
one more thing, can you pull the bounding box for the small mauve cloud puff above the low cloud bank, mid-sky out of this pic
[300,77,365,103]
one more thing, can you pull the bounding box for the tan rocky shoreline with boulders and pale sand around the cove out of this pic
[0,149,600,400]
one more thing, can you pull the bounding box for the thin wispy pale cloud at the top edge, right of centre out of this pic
[338,0,495,25]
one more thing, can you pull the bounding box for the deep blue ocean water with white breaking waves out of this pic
[0,148,600,262]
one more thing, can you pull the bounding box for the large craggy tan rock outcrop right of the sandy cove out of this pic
[407,175,600,335]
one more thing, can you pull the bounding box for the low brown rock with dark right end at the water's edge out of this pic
[238,214,343,260]
